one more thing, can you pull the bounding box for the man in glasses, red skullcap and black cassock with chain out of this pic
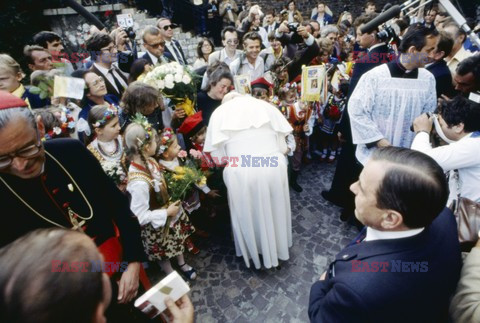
[0,91,146,322]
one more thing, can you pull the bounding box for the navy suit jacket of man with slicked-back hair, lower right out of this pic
[308,209,461,323]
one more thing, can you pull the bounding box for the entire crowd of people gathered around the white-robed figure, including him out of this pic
[0,0,480,322]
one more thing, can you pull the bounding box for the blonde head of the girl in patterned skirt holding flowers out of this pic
[124,118,157,162]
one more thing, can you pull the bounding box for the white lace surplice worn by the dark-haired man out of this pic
[348,64,437,165]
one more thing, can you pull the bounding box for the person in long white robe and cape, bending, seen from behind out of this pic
[204,94,292,269]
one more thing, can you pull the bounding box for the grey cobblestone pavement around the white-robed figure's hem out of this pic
[146,163,358,323]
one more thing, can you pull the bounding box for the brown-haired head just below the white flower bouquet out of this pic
[120,81,164,116]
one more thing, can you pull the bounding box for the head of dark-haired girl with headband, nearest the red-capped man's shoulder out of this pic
[88,105,120,142]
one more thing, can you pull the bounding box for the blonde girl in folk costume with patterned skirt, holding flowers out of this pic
[125,115,197,280]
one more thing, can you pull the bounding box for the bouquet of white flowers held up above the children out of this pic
[142,62,198,116]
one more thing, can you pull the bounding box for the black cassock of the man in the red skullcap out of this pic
[0,139,146,261]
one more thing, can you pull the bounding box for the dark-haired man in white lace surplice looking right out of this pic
[348,27,438,165]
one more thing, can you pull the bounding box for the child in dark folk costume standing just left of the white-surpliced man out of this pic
[318,82,348,163]
